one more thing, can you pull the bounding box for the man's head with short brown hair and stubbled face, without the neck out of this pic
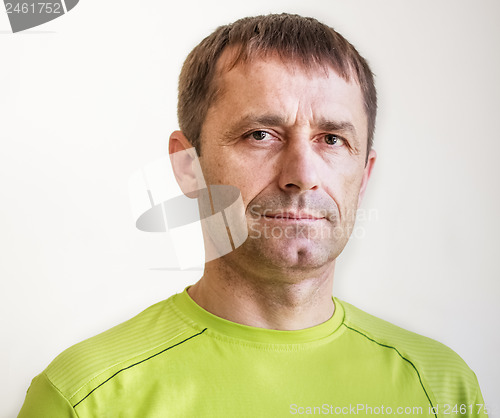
[170,15,376,274]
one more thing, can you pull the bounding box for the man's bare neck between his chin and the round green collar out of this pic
[188,259,335,330]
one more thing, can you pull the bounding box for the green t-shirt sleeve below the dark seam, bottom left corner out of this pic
[18,373,78,418]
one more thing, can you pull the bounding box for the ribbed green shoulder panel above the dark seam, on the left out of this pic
[44,295,197,400]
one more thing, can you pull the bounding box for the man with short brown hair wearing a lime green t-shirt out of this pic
[20,14,486,418]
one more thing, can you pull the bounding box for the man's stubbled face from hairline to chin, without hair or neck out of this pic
[197,52,375,270]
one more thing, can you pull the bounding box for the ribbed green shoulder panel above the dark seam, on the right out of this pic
[339,301,479,404]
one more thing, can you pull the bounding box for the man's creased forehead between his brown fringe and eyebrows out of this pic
[207,50,367,141]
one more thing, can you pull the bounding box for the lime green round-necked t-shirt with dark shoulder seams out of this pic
[19,290,486,418]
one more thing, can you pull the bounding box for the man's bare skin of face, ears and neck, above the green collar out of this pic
[170,51,376,330]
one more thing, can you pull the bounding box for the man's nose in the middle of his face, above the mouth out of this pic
[279,140,320,192]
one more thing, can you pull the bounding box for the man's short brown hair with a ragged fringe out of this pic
[177,13,377,158]
